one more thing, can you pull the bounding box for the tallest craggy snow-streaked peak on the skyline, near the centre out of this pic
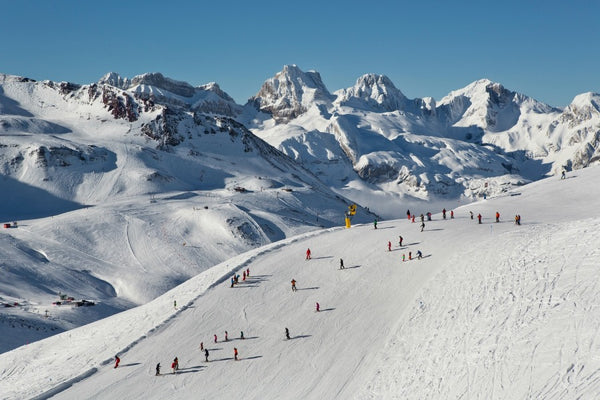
[249,65,333,122]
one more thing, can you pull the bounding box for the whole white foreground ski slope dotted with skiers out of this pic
[0,167,600,399]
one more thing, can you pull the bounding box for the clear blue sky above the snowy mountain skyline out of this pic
[0,0,600,107]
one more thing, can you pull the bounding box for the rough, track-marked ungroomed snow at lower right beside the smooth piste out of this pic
[365,220,600,399]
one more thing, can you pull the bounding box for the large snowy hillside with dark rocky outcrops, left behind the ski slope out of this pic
[0,74,373,351]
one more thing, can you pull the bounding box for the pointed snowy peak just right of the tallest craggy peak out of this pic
[336,74,407,111]
